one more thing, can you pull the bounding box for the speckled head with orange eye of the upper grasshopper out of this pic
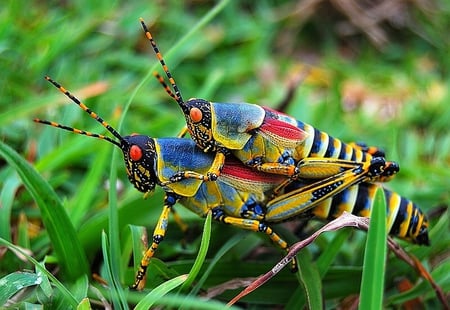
[182,98,217,151]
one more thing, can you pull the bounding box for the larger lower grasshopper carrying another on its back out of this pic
[35,77,428,289]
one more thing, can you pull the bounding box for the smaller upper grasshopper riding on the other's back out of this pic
[141,19,399,183]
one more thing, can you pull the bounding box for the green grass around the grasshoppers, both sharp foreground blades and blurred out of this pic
[0,1,450,309]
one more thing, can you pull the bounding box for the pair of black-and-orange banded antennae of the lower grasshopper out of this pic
[34,76,123,147]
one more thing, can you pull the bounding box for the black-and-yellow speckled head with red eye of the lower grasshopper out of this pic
[120,135,157,193]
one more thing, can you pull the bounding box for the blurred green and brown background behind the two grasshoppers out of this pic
[0,0,450,306]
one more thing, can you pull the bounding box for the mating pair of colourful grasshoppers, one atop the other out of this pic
[35,21,428,289]
